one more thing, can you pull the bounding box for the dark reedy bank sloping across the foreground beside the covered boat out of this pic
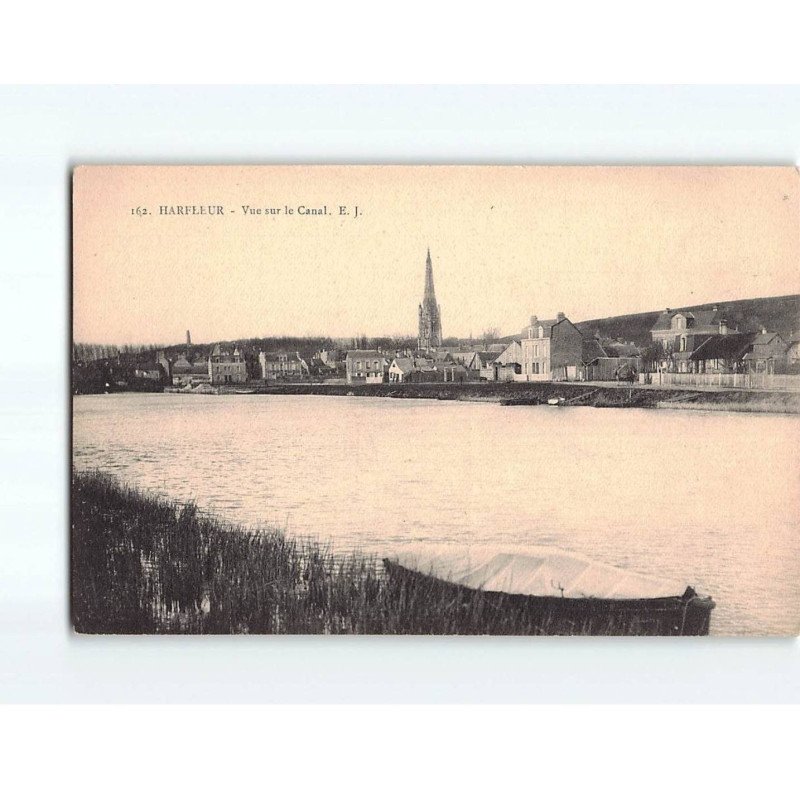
[71,472,656,635]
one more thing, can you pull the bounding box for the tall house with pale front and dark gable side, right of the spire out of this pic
[519,311,583,381]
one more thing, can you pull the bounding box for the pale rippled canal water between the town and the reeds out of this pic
[73,394,800,635]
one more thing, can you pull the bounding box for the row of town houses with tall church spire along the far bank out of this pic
[73,250,800,392]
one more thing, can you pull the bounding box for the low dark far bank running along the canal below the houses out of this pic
[181,381,800,414]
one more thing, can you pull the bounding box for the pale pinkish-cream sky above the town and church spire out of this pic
[73,166,800,344]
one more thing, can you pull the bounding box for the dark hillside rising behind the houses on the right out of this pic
[576,294,800,345]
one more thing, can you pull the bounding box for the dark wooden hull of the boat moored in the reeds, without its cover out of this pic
[384,559,715,636]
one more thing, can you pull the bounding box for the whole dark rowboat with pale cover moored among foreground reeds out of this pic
[384,550,715,636]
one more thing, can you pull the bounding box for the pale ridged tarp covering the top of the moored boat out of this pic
[389,549,686,600]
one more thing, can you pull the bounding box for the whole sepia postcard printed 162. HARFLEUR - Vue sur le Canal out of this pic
[71,166,800,636]
